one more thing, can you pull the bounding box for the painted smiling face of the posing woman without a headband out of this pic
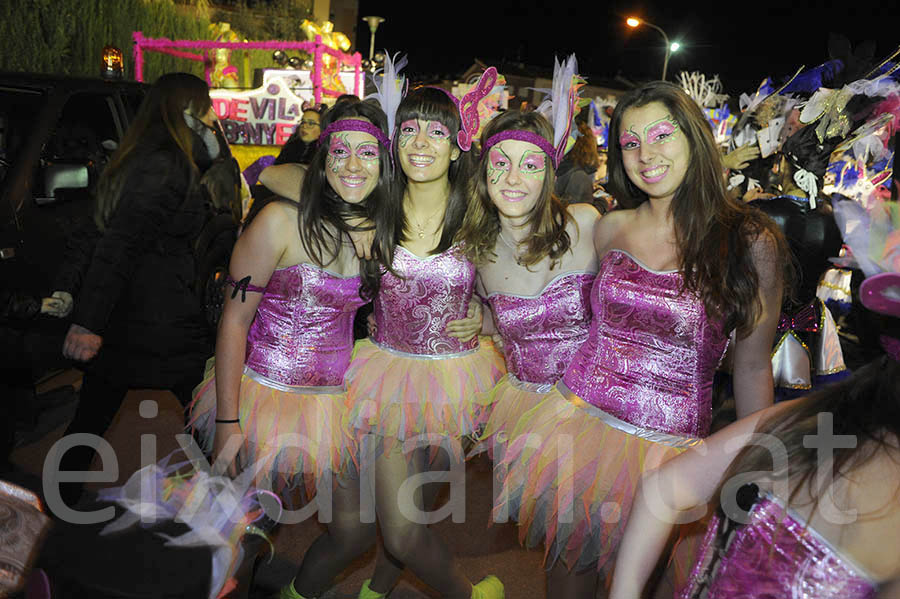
[618,102,691,205]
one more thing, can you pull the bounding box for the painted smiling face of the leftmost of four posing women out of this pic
[325,124,381,204]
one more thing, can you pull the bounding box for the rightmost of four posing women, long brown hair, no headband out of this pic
[495,82,788,598]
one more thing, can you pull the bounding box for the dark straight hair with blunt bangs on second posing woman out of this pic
[391,87,472,254]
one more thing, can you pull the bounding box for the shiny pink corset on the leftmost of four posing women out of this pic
[245,264,364,387]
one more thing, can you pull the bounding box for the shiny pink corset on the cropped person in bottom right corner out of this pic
[707,497,877,599]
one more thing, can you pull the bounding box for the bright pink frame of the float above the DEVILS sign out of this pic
[132,31,363,104]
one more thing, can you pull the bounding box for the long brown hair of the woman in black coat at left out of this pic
[94,73,212,231]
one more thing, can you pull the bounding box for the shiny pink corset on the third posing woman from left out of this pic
[487,272,596,384]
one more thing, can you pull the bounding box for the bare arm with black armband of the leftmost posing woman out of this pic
[214,204,288,474]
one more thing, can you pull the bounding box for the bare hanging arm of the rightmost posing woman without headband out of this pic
[734,235,782,418]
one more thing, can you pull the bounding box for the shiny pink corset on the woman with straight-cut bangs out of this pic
[374,245,478,356]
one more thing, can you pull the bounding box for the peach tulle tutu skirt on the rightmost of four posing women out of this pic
[493,384,699,572]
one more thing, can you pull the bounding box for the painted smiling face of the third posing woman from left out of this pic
[487,139,550,218]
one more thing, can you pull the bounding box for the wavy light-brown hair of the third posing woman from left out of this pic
[457,110,571,268]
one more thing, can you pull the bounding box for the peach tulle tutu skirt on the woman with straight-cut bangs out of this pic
[344,337,506,460]
